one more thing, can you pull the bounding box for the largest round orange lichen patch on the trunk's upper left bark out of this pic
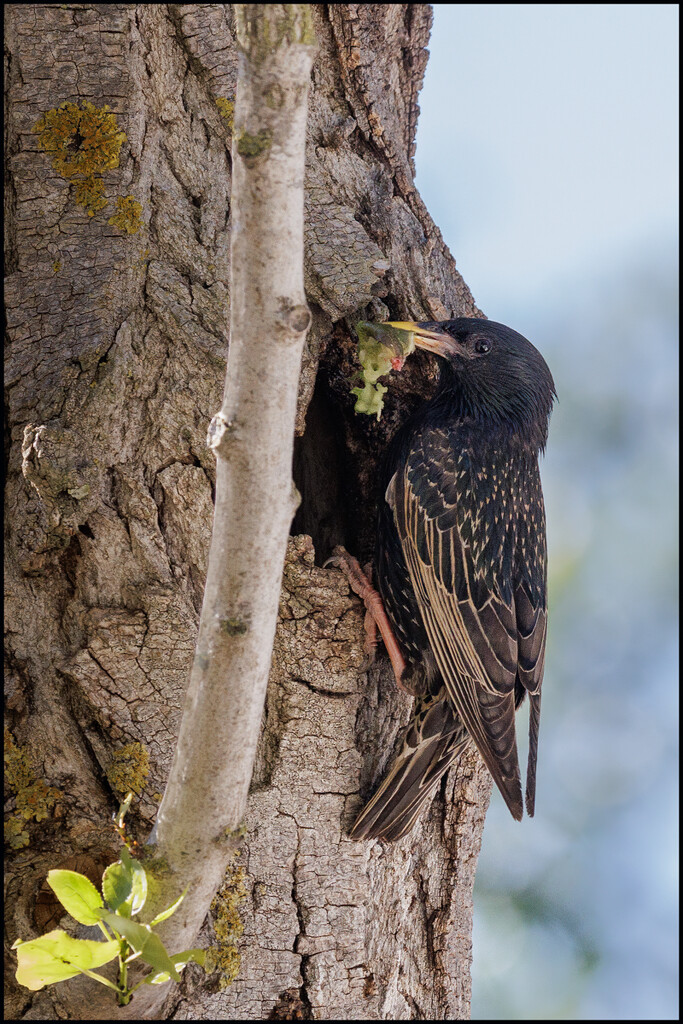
[33,100,126,178]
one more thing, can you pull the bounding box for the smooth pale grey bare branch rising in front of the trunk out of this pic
[133,4,314,1007]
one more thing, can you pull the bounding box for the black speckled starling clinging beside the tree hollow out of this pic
[350,318,555,840]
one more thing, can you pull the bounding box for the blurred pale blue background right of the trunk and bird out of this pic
[417,4,679,1020]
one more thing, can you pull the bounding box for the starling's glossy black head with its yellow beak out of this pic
[390,317,556,447]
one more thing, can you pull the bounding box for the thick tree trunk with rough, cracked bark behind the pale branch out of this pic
[5,4,490,1020]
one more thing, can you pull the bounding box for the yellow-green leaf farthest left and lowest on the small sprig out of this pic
[12,929,119,992]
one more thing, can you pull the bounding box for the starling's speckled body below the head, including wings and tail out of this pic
[350,423,547,841]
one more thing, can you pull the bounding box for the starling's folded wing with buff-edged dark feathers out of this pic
[386,431,522,820]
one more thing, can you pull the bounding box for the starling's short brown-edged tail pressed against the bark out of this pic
[349,699,469,842]
